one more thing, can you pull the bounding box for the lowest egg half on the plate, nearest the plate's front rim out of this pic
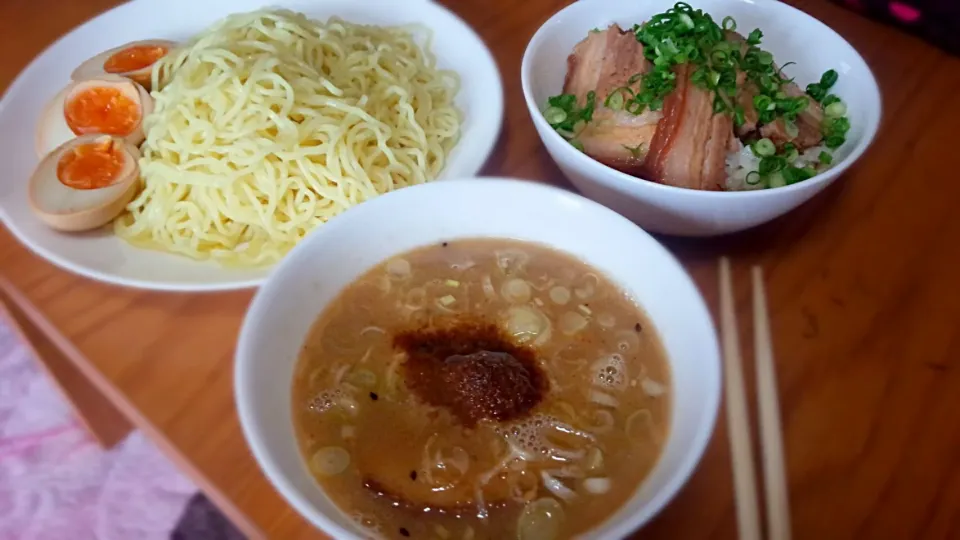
[29,134,140,231]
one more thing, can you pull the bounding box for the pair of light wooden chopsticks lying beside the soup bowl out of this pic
[720,257,790,540]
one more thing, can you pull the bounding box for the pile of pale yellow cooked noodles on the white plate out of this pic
[115,10,460,266]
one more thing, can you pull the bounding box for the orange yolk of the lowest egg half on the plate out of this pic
[57,139,126,189]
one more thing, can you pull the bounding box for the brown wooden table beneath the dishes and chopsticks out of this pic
[0,0,960,540]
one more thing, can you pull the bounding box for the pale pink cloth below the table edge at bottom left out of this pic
[0,318,197,540]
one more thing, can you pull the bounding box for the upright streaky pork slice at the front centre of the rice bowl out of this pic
[644,64,733,191]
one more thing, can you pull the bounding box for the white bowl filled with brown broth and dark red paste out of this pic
[236,179,720,539]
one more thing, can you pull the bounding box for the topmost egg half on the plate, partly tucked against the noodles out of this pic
[70,39,177,90]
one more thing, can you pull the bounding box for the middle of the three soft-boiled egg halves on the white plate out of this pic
[36,75,153,157]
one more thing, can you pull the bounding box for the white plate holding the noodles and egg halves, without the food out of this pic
[0,0,503,291]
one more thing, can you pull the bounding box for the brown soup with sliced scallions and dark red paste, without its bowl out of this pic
[293,239,672,540]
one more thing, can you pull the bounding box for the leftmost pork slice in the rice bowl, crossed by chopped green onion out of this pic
[563,24,660,174]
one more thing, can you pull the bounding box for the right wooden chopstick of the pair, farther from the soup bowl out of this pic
[751,266,790,540]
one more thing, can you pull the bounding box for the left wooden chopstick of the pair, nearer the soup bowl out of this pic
[720,257,760,540]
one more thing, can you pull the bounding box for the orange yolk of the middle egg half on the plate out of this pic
[63,86,140,137]
